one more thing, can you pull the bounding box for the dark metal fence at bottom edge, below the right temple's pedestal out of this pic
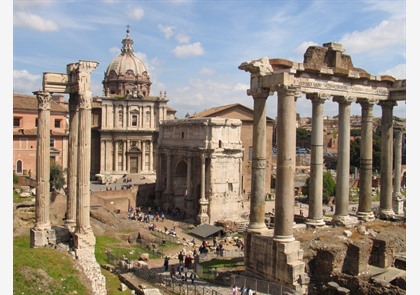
[231,275,296,295]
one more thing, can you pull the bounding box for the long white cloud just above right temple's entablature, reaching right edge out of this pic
[338,19,405,53]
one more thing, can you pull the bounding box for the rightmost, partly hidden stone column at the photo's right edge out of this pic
[392,127,404,214]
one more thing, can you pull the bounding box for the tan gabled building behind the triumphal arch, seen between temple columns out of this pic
[189,103,274,199]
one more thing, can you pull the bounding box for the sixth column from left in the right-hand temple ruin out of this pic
[379,100,397,219]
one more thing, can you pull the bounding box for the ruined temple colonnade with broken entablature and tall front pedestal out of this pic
[239,43,405,294]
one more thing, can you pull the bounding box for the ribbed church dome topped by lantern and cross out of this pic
[103,28,152,98]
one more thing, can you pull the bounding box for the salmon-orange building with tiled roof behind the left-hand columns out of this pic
[13,94,68,179]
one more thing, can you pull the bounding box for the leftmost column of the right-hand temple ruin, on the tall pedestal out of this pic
[247,88,270,232]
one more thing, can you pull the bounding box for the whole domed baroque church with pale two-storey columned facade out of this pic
[91,30,175,178]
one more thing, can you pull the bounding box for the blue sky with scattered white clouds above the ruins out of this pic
[13,0,406,118]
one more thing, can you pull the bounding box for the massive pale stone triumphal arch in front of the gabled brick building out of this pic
[154,118,245,224]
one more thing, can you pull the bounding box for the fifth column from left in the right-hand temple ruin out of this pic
[357,98,375,221]
